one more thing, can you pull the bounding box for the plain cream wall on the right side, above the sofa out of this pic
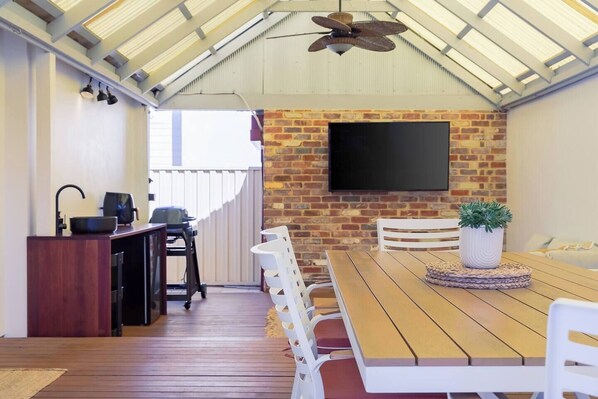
[507,75,598,250]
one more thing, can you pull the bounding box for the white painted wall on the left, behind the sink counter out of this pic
[0,31,148,337]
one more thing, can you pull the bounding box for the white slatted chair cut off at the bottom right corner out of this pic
[544,298,598,399]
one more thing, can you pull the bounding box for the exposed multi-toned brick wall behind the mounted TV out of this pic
[264,110,507,279]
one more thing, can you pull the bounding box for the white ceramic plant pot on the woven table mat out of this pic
[459,227,504,269]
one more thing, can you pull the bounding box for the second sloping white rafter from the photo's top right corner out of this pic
[436,0,554,82]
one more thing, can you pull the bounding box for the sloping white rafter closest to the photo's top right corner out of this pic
[500,0,594,65]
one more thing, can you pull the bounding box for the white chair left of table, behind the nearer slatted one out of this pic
[261,225,338,317]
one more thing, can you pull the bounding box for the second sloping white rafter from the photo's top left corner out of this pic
[87,0,184,64]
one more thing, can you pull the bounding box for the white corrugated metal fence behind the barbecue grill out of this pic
[149,168,262,285]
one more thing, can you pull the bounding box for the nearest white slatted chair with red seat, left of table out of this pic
[251,239,446,399]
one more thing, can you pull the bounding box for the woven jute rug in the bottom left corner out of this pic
[0,369,66,399]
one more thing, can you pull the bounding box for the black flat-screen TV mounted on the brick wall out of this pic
[328,122,450,191]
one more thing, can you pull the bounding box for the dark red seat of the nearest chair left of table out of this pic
[320,359,446,399]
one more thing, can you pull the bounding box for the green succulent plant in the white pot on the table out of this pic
[459,201,513,233]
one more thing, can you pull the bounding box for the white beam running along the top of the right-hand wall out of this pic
[500,58,598,109]
